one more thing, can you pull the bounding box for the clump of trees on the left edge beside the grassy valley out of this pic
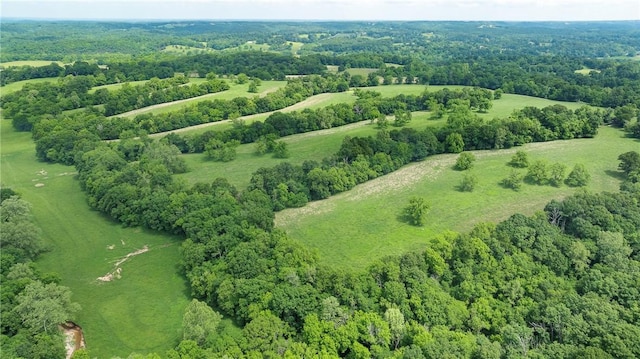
[0,195,79,359]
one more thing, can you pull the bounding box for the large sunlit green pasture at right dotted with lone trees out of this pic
[276,127,640,269]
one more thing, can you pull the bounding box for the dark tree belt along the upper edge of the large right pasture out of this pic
[245,106,603,210]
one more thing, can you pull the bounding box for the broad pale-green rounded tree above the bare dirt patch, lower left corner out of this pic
[13,281,80,334]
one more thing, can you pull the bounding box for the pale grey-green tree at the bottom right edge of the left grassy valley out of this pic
[182,299,222,346]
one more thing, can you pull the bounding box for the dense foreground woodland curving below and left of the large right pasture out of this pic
[70,134,640,358]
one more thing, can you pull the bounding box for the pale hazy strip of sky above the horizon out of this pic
[0,0,640,21]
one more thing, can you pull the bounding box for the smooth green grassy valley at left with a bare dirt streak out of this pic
[0,120,189,358]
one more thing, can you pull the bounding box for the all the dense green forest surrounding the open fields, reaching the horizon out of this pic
[0,21,640,359]
